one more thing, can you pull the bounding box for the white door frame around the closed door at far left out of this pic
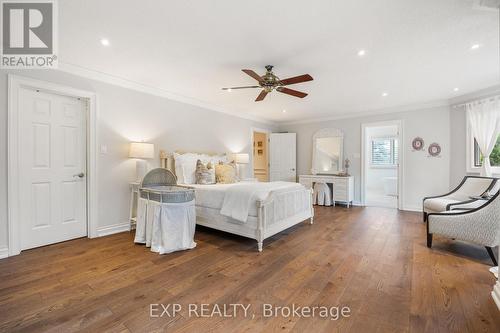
[7,74,98,256]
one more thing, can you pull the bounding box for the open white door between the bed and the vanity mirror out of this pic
[269,133,297,182]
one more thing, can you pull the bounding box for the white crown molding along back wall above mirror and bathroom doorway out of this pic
[279,100,450,126]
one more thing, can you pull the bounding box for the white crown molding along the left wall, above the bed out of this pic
[56,61,278,126]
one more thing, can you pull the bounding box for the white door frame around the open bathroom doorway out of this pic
[360,119,405,210]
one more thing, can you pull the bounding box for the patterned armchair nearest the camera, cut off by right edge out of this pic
[427,191,500,266]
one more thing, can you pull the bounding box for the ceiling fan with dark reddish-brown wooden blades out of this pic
[222,65,313,102]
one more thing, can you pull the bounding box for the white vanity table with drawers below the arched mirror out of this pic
[299,175,354,208]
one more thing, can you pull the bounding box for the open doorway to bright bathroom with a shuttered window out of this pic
[362,121,401,208]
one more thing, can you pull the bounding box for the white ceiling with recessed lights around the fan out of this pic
[59,0,499,122]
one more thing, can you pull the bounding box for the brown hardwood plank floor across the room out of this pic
[0,207,500,332]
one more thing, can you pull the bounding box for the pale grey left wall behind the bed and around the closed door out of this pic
[0,70,276,249]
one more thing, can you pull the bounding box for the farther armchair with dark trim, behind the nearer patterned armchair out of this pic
[422,176,498,222]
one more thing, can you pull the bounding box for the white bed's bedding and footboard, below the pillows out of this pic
[162,152,314,252]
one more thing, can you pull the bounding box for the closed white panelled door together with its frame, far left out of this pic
[7,75,98,256]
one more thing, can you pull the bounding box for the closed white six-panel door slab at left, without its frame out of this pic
[19,89,87,250]
